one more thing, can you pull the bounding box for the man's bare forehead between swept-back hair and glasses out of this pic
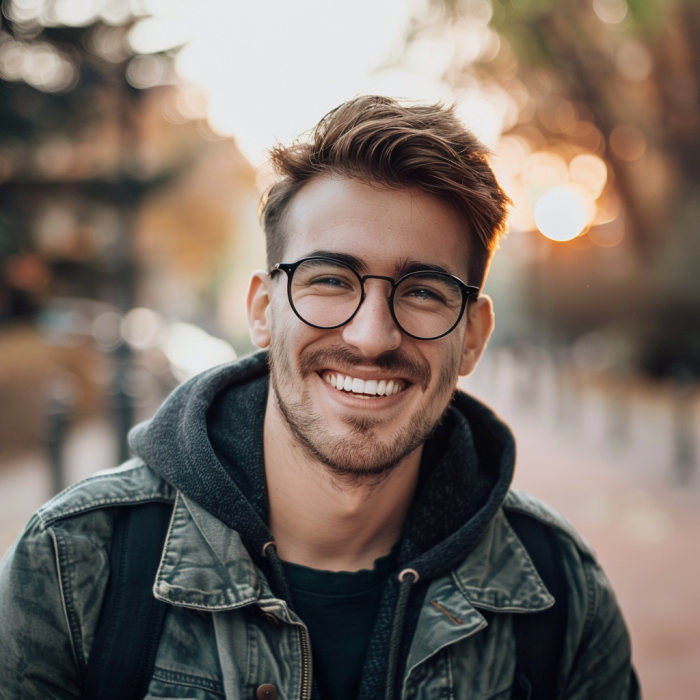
[285,176,468,279]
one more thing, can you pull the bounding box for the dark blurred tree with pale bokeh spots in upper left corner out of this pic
[0,0,178,317]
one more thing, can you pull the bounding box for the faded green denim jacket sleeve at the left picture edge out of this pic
[0,515,81,700]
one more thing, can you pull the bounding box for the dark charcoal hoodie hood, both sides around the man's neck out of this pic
[129,352,515,579]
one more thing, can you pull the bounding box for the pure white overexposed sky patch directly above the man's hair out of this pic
[130,0,445,165]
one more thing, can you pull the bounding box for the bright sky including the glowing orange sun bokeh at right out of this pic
[126,0,608,241]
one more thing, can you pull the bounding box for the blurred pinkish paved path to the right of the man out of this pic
[463,366,700,700]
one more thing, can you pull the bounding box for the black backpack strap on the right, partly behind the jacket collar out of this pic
[506,511,569,700]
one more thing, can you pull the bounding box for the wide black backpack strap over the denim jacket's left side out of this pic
[81,502,173,700]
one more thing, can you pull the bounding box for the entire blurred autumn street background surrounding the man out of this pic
[0,0,700,700]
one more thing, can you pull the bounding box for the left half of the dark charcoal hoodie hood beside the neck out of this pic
[129,353,272,563]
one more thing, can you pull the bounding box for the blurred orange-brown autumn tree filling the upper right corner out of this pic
[408,0,700,375]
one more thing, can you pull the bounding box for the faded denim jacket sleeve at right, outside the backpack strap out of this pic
[559,540,641,700]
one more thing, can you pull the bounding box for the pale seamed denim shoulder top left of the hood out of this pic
[37,458,176,527]
